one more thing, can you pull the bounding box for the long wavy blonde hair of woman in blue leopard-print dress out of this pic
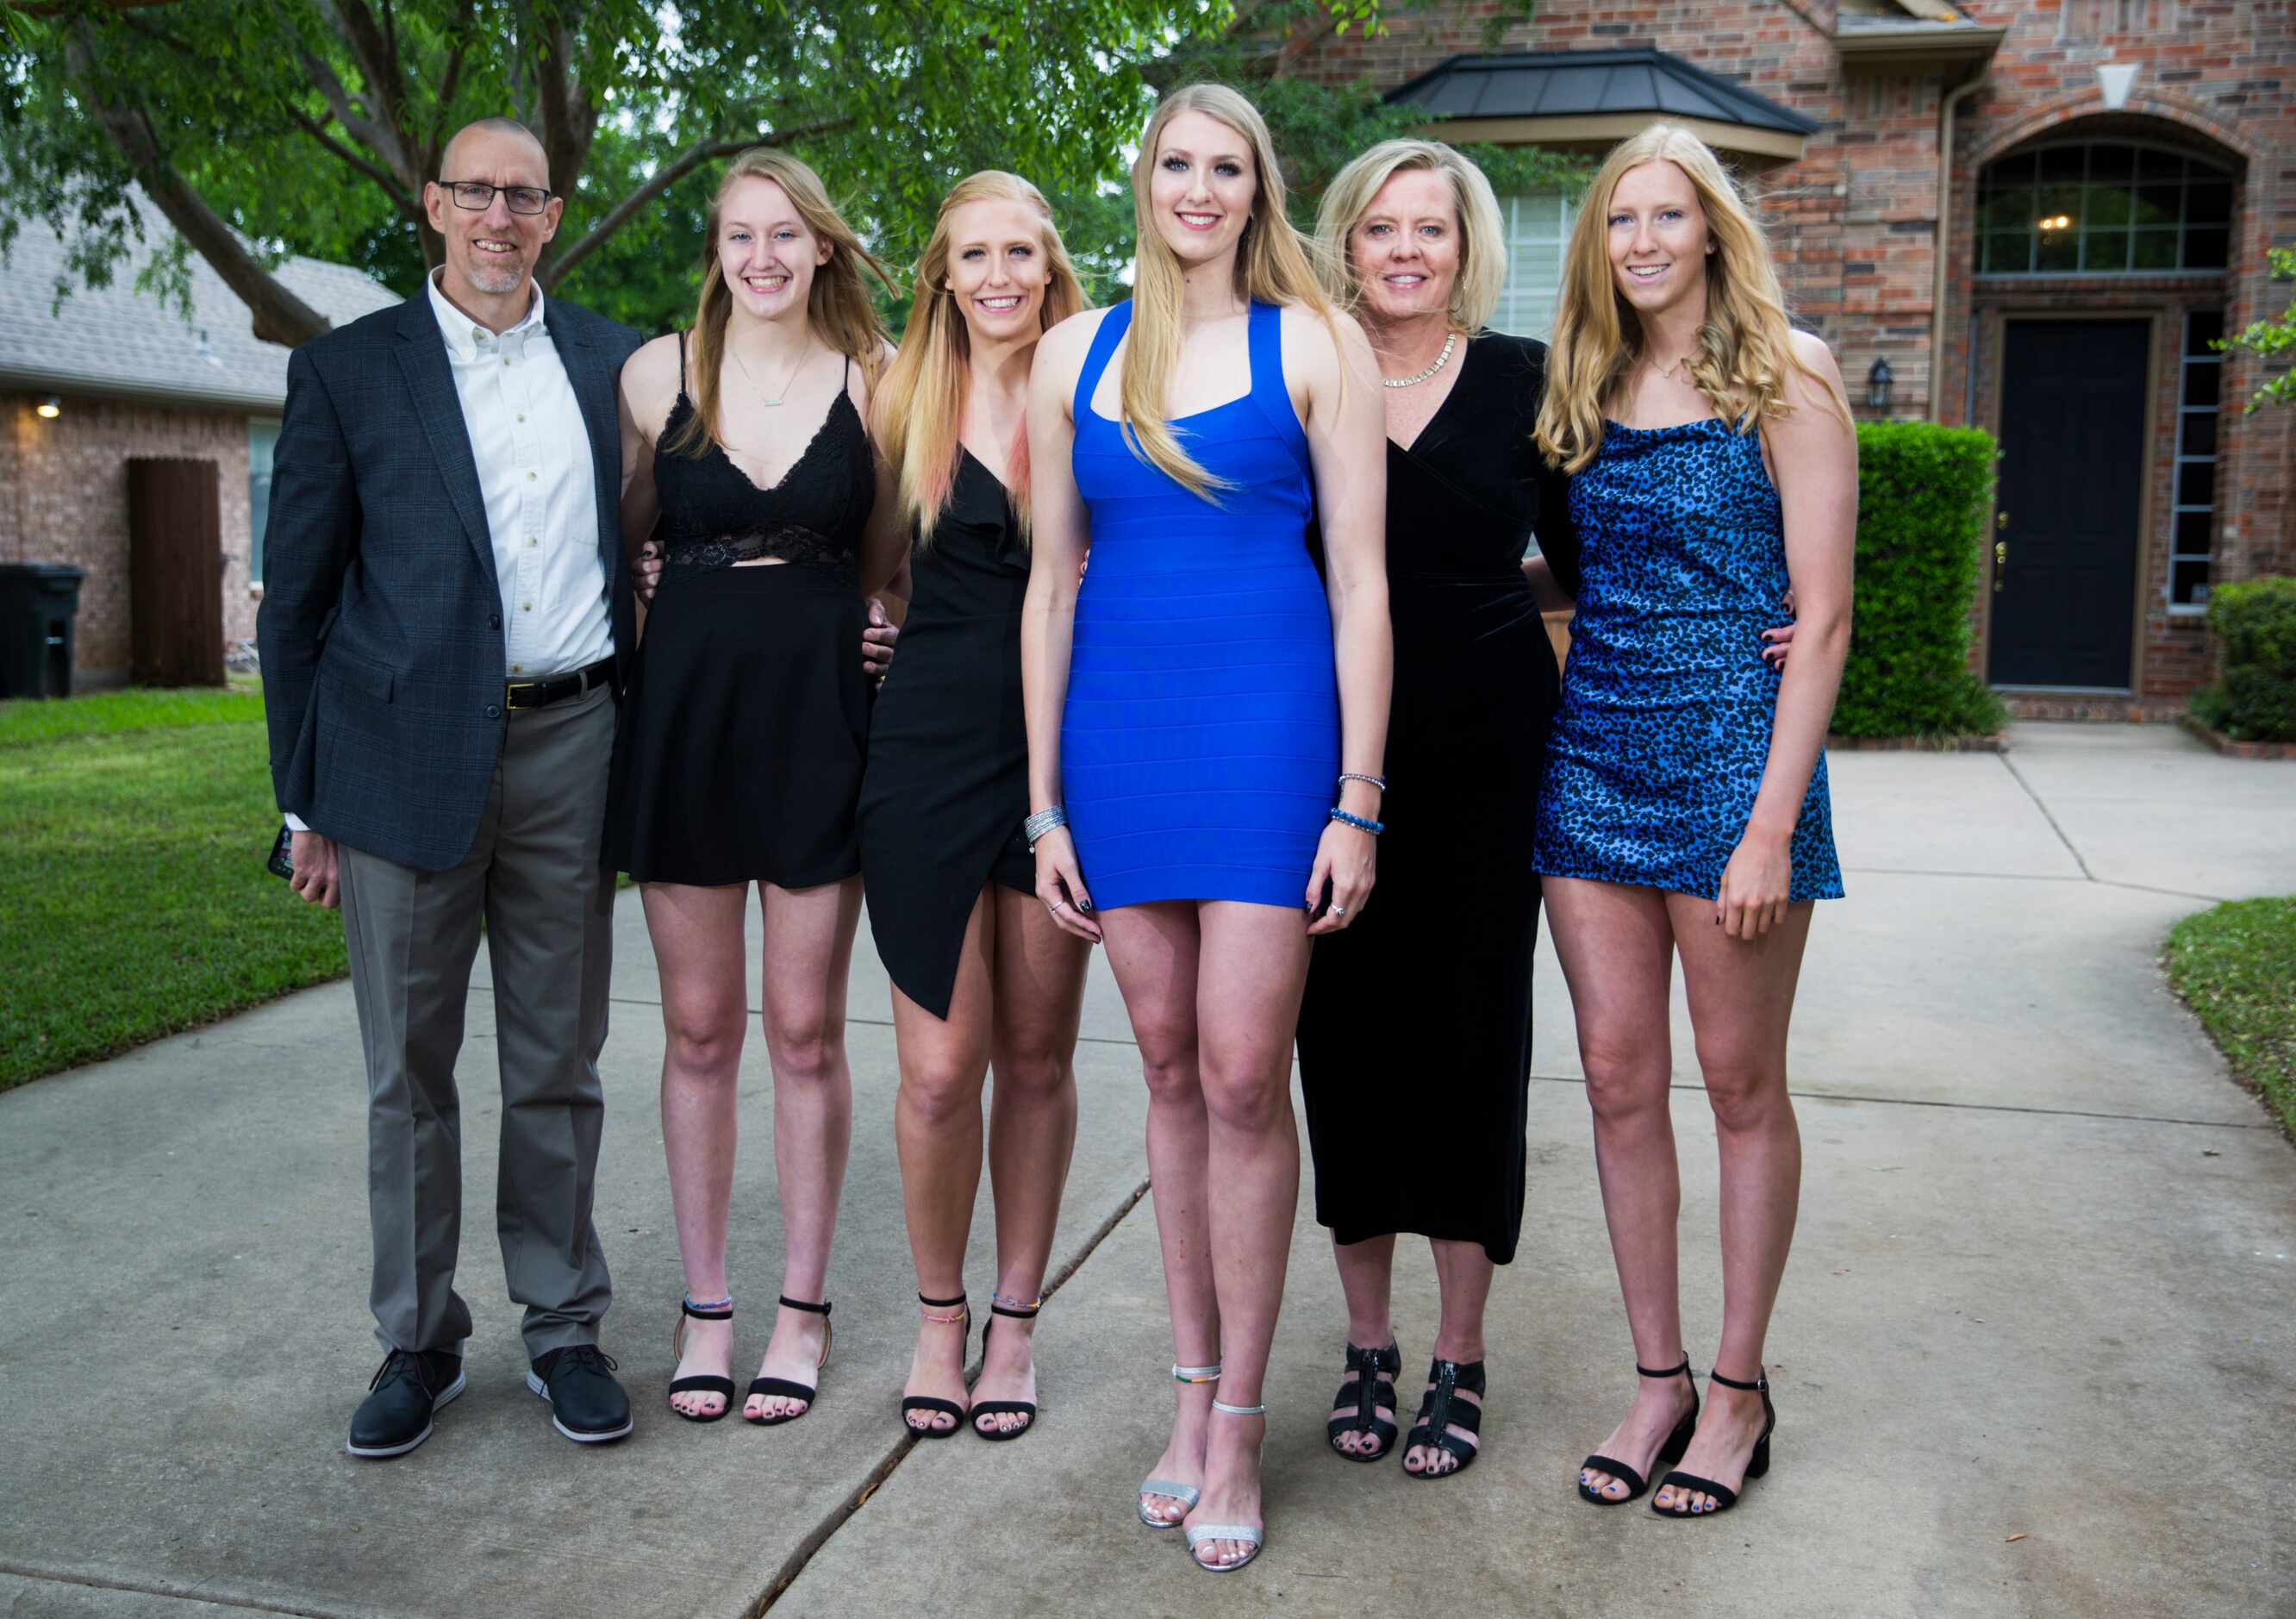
[1534,124,1849,473]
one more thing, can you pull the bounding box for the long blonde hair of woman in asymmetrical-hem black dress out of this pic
[870,167,1083,547]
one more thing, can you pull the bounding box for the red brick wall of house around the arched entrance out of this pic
[1282,0,2296,698]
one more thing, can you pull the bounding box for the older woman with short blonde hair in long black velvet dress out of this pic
[1300,140,1577,1479]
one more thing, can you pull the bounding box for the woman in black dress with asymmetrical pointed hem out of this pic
[861,170,1090,1440]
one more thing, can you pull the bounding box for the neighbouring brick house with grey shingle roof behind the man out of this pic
[0,214,397,689]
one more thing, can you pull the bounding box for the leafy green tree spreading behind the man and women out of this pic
[0,0,1584,345]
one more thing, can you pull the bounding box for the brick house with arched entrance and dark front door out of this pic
[1272,0,2296,712]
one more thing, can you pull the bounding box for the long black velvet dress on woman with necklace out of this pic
[1300,333,1577,1266]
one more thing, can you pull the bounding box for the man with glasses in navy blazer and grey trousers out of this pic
[257,120,639,1456]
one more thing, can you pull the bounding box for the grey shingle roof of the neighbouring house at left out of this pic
[0,209,400,413]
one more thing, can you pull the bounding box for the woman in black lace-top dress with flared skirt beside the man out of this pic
[606,149,900,1426]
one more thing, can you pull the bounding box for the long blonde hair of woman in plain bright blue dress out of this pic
[1118,85,1336,501]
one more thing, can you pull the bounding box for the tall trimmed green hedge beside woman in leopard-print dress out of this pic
[1835,422,2005,737]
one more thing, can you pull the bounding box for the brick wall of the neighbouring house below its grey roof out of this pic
[0,395,255,686]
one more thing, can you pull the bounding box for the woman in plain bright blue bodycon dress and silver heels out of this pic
[1021,85,1389,1573]
